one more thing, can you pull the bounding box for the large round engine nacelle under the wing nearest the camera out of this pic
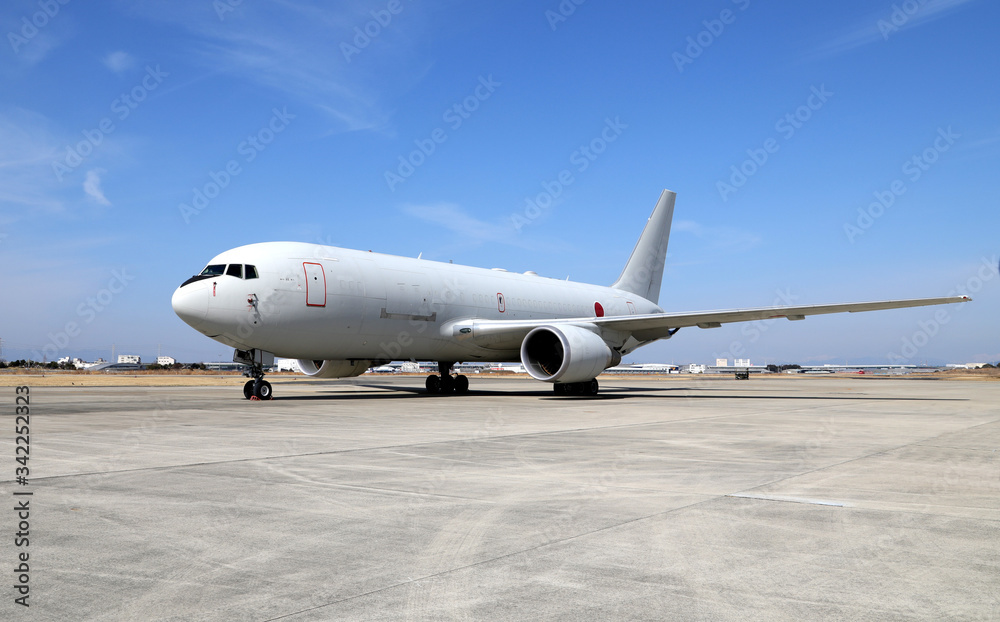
[521,326,622,383]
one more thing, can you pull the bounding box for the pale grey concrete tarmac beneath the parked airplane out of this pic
[0,376,1000,622]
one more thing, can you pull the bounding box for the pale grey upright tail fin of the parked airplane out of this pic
[611,190,677,303]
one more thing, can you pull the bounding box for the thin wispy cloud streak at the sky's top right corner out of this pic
[813,0,977,57]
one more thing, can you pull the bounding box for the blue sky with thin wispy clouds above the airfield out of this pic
[0,0,1000,363]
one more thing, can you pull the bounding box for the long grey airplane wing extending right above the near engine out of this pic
[453,296,972,346]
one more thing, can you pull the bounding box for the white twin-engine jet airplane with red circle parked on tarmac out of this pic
[171,190,970,400]
